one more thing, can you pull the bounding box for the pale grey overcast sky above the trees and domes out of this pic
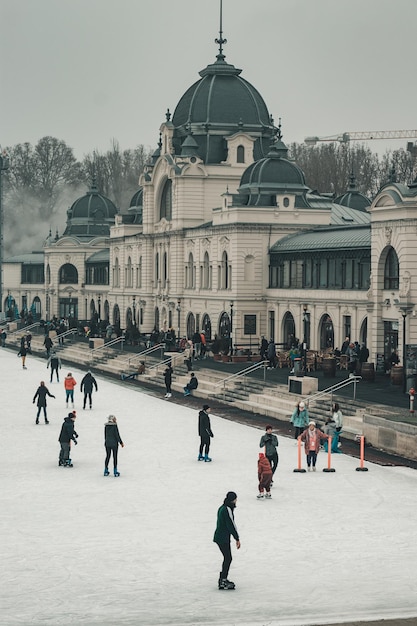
[0,0,417,158]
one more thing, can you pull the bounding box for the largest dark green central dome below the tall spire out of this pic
[172,54,275,163]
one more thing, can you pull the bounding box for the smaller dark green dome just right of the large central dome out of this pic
[238,137,308,206]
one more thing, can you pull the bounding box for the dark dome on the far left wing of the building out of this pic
[63,181,118,237]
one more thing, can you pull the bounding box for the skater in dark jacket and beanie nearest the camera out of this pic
[213,491,240,590]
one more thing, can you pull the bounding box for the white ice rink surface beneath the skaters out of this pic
[0,350,417,626]
